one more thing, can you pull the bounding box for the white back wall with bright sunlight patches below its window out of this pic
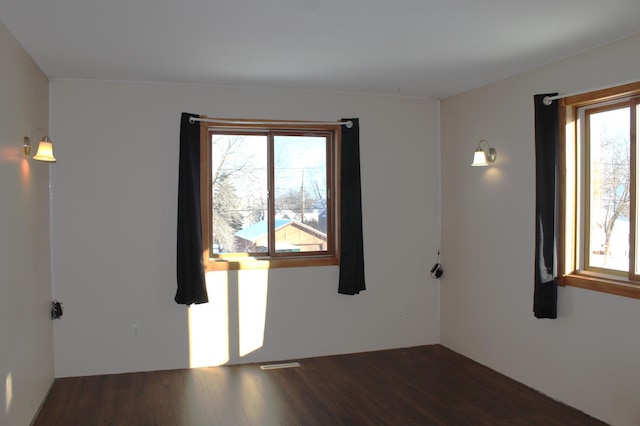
[51,80,440,377]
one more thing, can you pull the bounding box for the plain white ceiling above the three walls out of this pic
[0,0,640,98]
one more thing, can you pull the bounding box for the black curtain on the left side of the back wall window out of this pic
[175,112,209,305]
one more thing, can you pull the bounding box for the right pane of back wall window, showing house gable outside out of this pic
[273,135,327,253]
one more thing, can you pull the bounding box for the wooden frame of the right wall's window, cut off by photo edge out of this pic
[558,82,640,299]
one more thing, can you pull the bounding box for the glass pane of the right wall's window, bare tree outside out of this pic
[588,107,631,271]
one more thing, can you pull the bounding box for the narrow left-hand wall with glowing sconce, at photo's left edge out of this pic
[0,23,53,426]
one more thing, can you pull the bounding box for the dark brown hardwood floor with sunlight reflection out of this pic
[34,345,604,426]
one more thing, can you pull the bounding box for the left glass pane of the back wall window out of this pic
[211,134,269,254]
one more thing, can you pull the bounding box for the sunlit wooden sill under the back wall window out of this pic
[205,256,339,272]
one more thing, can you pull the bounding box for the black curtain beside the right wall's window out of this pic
[533,93,560,318]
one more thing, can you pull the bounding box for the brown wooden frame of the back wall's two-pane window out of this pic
[200,116,341,271]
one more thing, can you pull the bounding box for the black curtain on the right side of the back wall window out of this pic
[338,118,366,295]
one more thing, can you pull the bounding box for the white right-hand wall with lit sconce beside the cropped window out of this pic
[441,33,640,425]
